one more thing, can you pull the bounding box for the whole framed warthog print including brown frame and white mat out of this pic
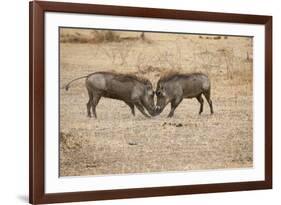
[30,1,272,204]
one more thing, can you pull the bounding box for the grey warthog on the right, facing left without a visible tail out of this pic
[156,73,214,117]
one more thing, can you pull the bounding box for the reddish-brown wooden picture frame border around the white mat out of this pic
[29,1,272,204]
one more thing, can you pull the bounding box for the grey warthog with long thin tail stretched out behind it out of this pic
[65,72,155,118]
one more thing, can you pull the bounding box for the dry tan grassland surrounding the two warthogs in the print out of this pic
[60,28,253,176]
